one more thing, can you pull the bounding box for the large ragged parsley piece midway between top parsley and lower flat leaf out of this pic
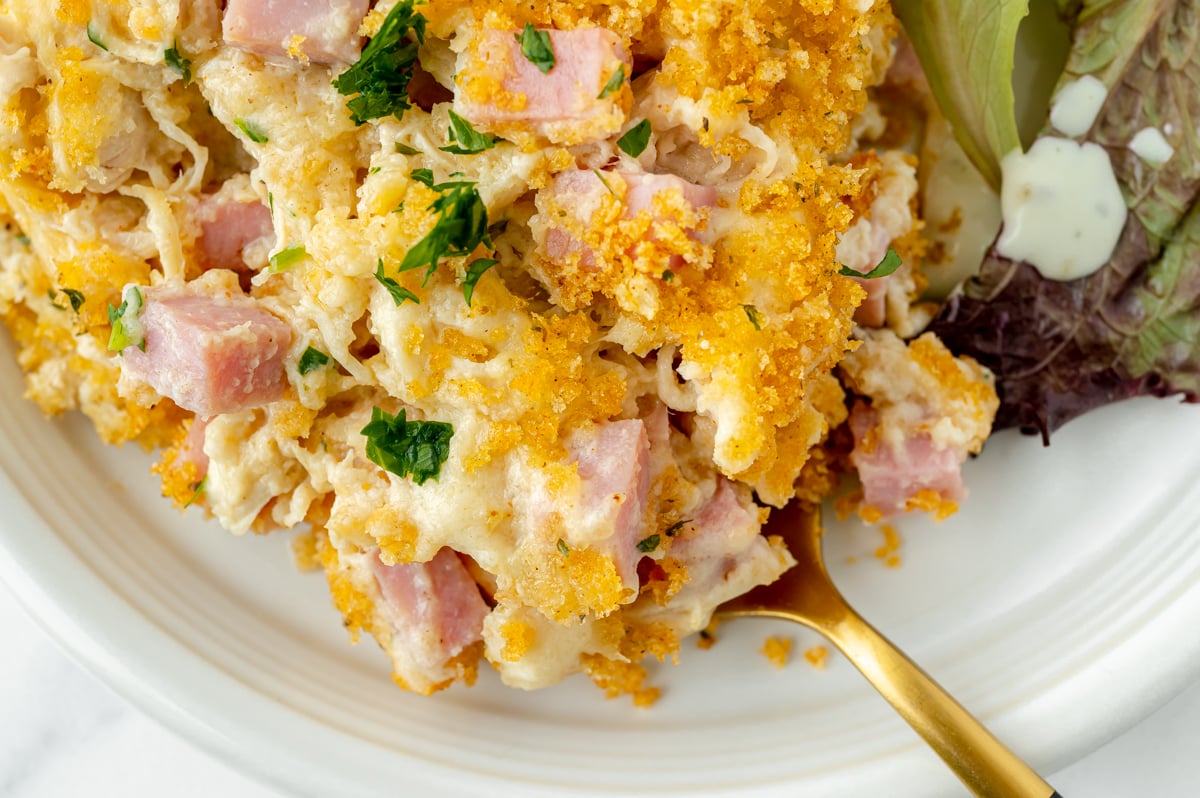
[400,177,492,280]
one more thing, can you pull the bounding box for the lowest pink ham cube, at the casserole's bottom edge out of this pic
[371,548,488,676]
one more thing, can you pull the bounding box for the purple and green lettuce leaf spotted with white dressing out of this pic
[930,0,1200,442]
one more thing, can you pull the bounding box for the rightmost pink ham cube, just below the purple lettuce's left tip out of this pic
[850,402,966,516]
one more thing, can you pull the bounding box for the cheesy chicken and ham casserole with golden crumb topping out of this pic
[0,0,997,704]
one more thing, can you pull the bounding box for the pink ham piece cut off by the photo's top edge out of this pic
[222,0,370,64]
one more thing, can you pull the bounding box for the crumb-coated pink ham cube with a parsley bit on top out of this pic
[456,28,632,144]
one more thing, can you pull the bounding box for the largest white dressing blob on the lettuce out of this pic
[996,137,1128,281]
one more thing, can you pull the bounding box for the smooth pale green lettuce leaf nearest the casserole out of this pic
[893,0,1030,191]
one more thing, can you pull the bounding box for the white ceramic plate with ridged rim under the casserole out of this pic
[0,326,1200,798]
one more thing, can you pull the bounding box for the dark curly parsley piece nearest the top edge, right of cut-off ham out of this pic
[334,0,425,125]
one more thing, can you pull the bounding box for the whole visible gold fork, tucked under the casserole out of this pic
[718,502,1061,798]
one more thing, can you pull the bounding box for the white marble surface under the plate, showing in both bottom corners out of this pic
[0,578,1200,798]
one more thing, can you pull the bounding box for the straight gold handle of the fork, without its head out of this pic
[822,607,1061,798]
